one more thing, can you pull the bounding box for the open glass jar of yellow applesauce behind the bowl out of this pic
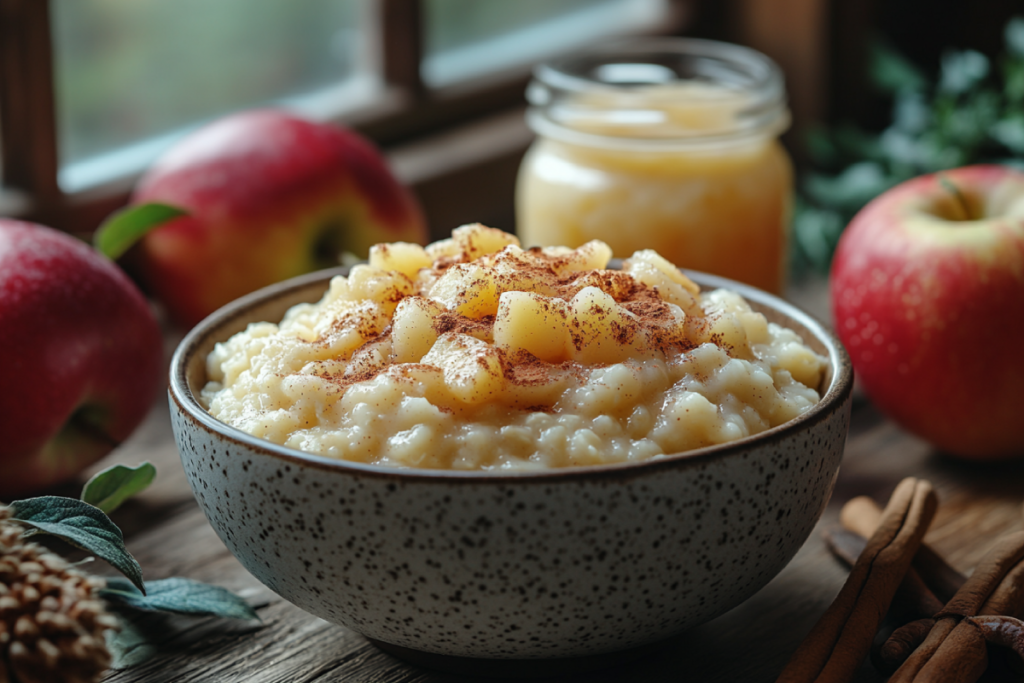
[516,39,793,294]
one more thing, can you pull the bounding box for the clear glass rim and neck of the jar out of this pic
[526,38,790,145]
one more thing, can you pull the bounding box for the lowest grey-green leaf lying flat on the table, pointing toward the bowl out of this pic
[100,578,259,620]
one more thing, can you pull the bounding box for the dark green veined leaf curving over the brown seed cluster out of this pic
[10,496,145,593]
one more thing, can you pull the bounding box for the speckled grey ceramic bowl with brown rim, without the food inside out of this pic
[170,270,852,659]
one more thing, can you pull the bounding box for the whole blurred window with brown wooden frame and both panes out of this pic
[0,0,691,232]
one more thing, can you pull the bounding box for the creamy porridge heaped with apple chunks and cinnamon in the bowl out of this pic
[202,224,825,471]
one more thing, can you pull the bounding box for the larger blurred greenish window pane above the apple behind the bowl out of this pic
[51,0,377,189]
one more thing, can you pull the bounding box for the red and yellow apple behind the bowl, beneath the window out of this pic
[131,110,427,326]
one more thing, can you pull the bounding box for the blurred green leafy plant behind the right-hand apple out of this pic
[793,17,1024,273]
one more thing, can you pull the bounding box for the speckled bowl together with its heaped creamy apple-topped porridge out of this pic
[170,225,852,666]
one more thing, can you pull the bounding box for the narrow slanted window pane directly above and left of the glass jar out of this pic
[423,0,670,86]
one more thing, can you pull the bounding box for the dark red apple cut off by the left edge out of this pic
[0,219,164,501]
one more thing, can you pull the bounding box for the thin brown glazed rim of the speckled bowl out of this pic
[168,266,853,483]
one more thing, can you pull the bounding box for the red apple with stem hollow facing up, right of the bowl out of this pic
[831,165,1024,460]
